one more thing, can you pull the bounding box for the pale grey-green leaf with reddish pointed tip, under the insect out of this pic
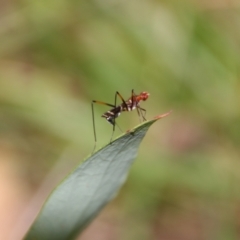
[25,112,170,240]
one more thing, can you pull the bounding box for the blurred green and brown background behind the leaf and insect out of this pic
[0,0,240,240]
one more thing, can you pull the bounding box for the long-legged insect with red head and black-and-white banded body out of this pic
[92,90,150,152]
